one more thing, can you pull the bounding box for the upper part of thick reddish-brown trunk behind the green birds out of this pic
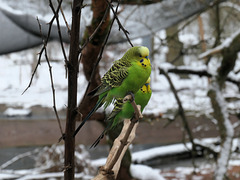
[79,0,110,120]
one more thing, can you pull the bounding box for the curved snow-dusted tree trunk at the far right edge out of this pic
[208,25,240,180]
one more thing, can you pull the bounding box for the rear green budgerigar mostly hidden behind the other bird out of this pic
[91,78,152,147]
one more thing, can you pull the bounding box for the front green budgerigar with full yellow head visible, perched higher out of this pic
[74,46,151,136]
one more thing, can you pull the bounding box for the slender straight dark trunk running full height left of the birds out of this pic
[64,0,82,180]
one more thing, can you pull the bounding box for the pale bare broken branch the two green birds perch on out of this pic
[93,95,143,180]
